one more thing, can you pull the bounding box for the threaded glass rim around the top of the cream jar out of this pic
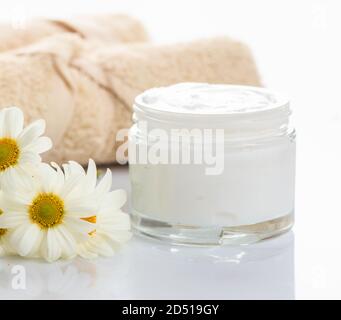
[133,84,291,139]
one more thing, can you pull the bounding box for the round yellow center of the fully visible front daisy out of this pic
[28,193,65,229]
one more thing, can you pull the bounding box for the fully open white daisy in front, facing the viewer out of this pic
[0,164,97,261]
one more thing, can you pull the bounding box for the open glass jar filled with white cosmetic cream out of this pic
[129,83,295,245]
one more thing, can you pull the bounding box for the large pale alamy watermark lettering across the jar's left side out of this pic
[116,121,225,175]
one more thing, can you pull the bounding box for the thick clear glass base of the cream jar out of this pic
[131,212,294,246]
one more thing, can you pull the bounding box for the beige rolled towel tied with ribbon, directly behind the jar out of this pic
[0,34,260,164]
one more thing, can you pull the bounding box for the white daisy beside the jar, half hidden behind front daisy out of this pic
[64,159,131,258]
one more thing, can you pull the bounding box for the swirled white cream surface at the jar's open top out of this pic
[140,83,287,114]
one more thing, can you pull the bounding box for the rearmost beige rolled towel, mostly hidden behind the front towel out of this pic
[0,14,147,52]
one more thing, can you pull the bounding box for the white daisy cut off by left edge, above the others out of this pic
[0,107,52,184]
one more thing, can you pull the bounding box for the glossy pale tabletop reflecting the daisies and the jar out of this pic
[0,232,295,299]
